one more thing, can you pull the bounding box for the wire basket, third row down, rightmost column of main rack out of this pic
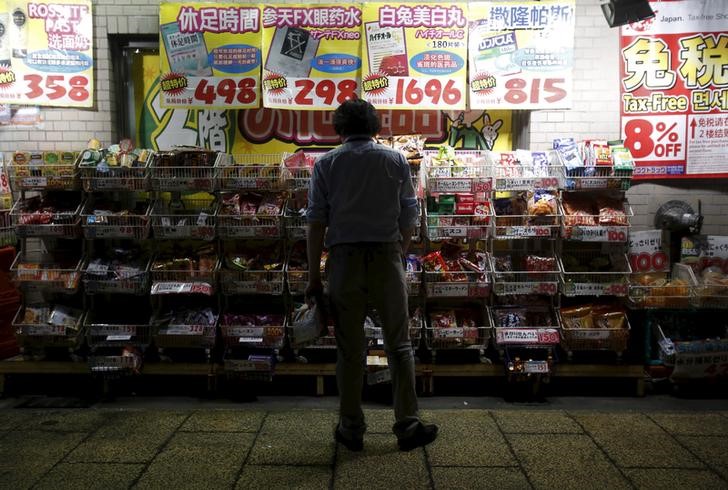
[558,250,632,296]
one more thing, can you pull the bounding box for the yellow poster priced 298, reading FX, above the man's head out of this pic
[263,4,362,110]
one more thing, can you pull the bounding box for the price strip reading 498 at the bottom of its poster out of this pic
[160,73,259,109]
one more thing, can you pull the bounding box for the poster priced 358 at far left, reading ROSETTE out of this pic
[0,0,94,107]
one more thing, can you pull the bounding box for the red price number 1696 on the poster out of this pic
[394,77,463,108]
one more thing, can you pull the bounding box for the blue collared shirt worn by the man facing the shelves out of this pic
[306,136,418,247]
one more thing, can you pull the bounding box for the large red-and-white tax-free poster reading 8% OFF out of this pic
[620,0,728,179]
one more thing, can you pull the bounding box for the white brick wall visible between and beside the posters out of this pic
[0,0,728,235]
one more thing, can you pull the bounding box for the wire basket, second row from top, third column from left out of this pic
[150,199,218,240]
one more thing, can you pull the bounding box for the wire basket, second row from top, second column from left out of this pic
[81,202,152,240]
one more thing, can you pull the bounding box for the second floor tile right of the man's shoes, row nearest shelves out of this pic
[492,410,584,434]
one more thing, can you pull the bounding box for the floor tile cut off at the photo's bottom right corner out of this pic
[624,468,726,490]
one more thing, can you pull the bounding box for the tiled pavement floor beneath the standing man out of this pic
[0,399,728,490]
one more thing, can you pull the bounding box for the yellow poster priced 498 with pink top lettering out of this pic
[159,3,261,109]
